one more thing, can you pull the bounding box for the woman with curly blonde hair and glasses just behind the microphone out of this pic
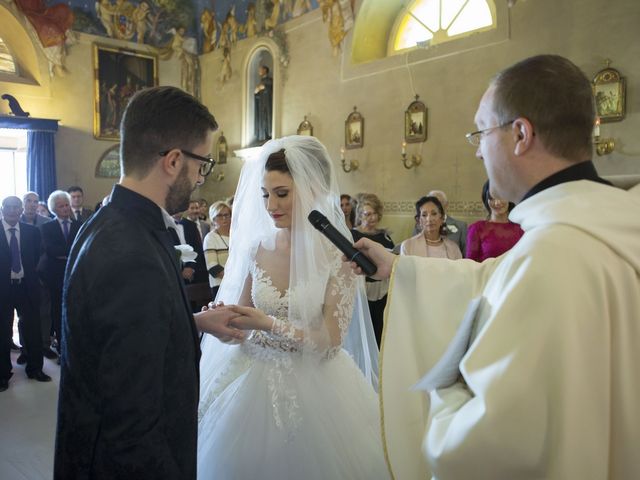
[351,193,394,347]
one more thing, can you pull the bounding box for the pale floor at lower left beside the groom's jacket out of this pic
[0,326,60,480]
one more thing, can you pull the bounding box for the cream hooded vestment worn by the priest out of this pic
[380,181,640,480]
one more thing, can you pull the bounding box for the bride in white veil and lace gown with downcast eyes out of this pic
[198,136,389,480]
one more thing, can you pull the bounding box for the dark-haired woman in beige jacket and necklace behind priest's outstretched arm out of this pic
[400,196,462,260]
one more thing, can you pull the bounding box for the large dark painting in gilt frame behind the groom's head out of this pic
[93,44,158,140]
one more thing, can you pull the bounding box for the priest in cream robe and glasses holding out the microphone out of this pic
[354,55,640,480]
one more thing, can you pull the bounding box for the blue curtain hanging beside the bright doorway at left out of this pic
[27,131,57,199]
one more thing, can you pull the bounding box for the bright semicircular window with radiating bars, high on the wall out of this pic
[391,0,496,52]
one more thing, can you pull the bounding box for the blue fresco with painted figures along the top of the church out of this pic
[44,0,318,53]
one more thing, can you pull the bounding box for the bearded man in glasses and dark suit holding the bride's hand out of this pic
[54,87,243,480]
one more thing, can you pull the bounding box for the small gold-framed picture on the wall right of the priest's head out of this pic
[592,61,626,123]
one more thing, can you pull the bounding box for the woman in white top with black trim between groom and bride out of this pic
[203,202,231,298]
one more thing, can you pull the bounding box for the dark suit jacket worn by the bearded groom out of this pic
[54,185,200,480]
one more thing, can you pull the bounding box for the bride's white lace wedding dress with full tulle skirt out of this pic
[198,259,389,480]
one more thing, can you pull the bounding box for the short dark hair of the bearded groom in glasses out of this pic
[120,87,218,179]
